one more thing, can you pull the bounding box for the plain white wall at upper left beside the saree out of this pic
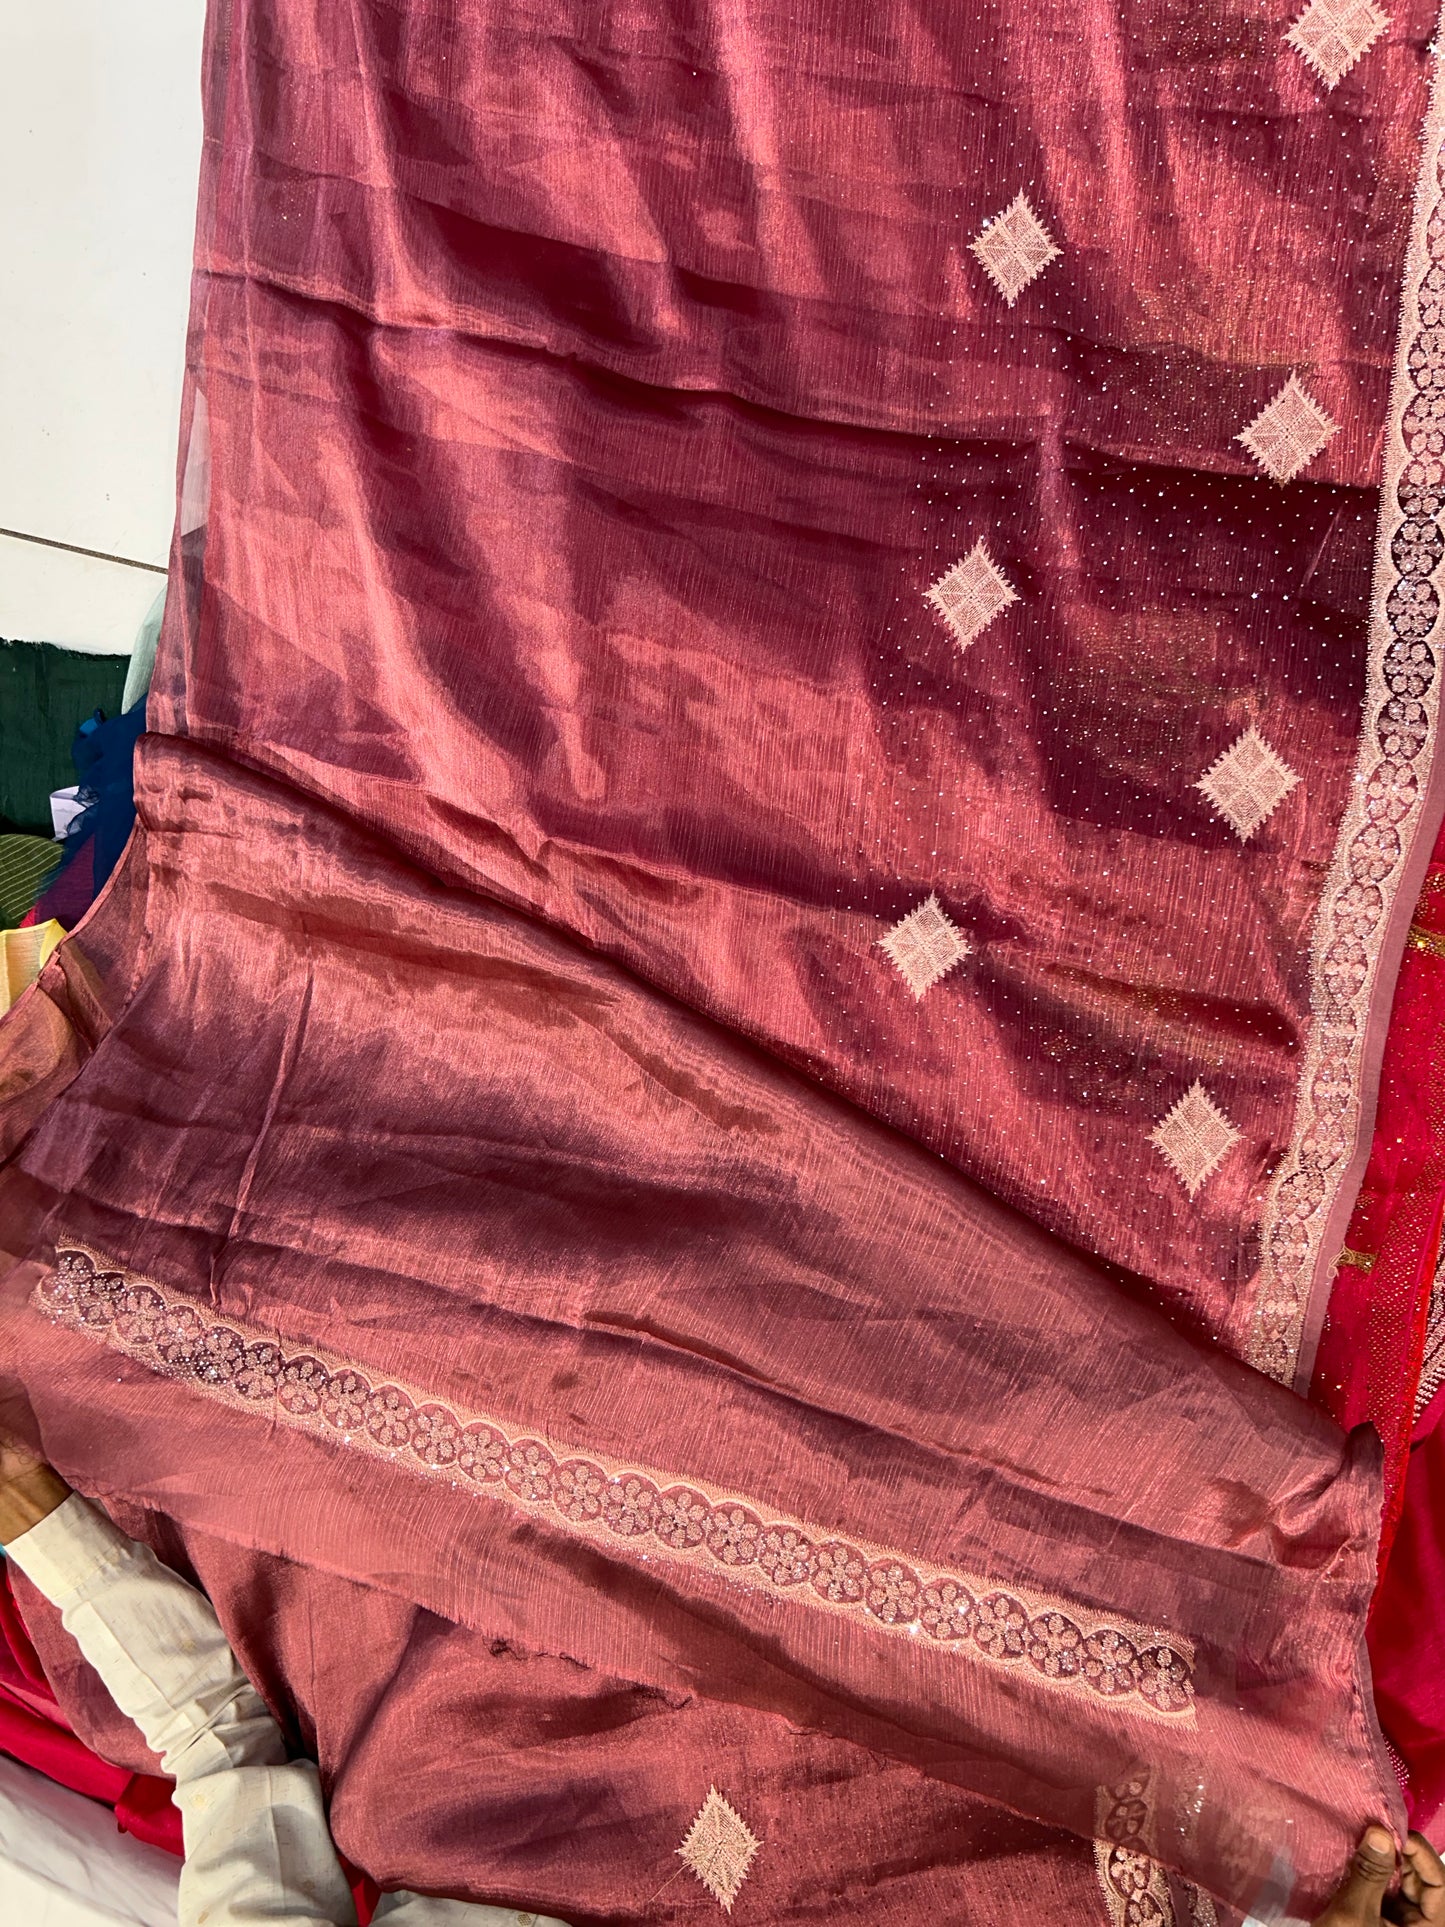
[0,0,204,653]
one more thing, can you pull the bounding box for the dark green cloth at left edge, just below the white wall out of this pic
[0,642,129,836]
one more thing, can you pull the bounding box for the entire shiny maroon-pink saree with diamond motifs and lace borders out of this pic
[0,0,1445,1927]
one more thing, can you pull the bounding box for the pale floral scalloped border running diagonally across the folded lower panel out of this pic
[42,1243,1195,1725]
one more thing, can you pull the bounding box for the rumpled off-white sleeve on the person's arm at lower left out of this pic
[6,1493,563,1927]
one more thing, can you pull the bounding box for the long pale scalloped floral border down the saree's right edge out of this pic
[1245,33,1445,1384]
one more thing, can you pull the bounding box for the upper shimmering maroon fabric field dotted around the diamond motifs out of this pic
[166,0,1439,1382]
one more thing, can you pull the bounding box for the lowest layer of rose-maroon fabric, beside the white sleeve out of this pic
[8,1515,1140,1921]
